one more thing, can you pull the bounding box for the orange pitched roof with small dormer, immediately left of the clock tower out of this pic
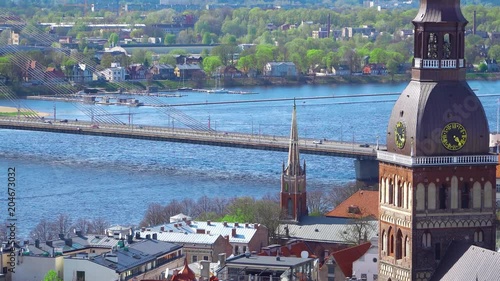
[325,190,378,219]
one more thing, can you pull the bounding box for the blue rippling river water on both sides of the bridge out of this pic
[0,81,500,237]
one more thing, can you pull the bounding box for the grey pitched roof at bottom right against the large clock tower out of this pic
[430,241,500,281]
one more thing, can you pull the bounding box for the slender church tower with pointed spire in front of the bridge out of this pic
[280,102,308,221]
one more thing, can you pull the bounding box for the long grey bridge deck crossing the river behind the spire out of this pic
[0,117,383,159]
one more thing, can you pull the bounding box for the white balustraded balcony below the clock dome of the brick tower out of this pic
[377,151,498,167]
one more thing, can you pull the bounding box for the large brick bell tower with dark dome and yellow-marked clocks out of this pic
[378,0,497,281]
